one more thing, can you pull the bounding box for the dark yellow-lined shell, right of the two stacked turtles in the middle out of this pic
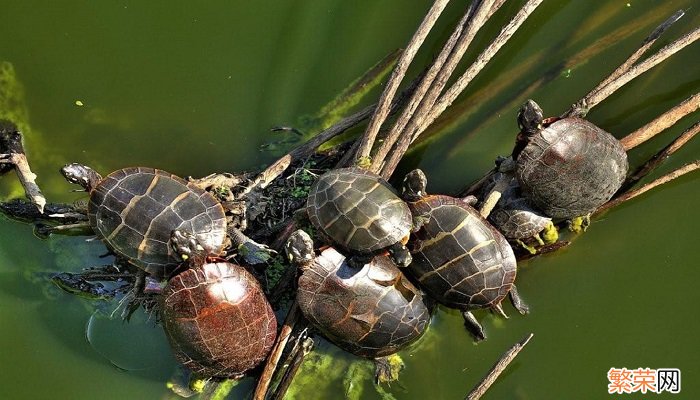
[407,195,516,310]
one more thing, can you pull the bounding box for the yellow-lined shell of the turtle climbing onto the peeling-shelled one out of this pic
[307,168,412,253]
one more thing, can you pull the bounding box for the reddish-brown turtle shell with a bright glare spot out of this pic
[160,262,277,377]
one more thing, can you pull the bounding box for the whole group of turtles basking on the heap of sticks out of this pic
[62,101,627,377]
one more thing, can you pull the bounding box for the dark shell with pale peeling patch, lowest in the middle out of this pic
[297,248,430,358]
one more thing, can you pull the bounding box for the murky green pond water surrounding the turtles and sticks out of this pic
[0,0,700,399]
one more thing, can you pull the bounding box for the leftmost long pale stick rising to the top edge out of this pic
[357,0,449,164]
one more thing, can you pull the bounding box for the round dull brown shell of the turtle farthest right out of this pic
[516,117,628,218]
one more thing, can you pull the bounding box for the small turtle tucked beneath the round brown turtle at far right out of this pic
[483,172,559,254]
